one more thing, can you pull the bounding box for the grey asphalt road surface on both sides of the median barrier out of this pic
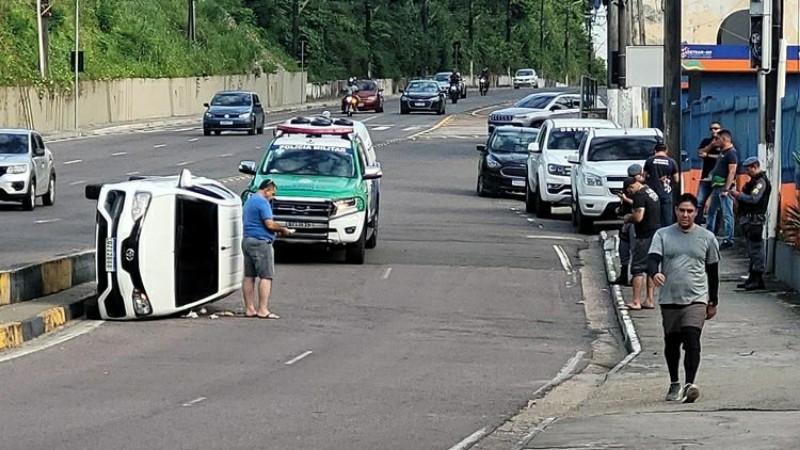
[0,86,599,450]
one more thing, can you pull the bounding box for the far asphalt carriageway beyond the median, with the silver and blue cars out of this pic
[0,85,564,268]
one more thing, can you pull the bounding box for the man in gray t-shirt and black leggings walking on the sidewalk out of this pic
[647,194,719,403]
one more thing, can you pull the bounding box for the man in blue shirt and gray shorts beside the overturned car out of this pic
[242,180,294,319]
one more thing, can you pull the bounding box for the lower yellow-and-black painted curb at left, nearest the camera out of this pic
[0,288,96,351]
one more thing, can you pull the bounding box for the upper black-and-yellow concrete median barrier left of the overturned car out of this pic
[0,250,95,306]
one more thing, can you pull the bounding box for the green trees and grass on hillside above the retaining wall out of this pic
[0,0,605,85]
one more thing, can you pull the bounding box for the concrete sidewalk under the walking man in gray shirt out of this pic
[521,232,800,450]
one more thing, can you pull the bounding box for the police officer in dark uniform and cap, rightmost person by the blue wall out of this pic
[731,156,772,291]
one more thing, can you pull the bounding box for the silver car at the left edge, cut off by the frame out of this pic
[0,129,56,211]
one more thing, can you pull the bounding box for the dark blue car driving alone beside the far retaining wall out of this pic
[203,91,265,136]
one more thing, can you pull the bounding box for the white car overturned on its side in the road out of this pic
[85,169,244,320]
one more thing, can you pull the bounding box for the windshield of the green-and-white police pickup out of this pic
[262,144,355,178]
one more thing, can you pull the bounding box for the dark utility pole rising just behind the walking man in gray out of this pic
[663,0,683,196]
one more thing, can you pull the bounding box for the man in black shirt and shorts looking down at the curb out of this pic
[622,177,661,309]
